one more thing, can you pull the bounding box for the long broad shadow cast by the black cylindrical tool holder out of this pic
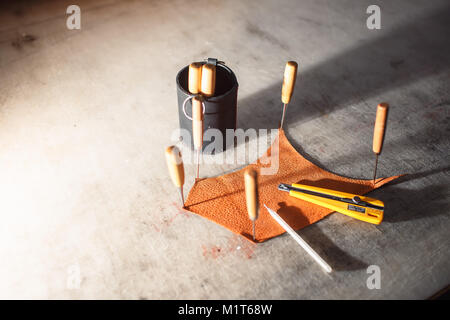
[238,6,450,129]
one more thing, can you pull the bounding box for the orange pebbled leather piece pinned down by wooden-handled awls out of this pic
[185,130,400,242]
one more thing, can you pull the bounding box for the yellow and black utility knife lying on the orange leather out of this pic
[278,183,384,224]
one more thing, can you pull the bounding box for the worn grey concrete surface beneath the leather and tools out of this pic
[0,0,450,299]
